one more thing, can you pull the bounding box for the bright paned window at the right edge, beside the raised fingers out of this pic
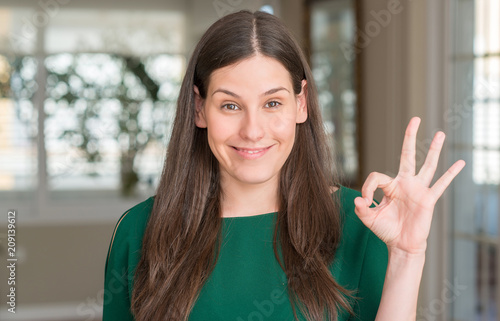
[452,0,500,320]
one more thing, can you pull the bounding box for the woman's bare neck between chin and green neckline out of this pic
[221,176,279,217]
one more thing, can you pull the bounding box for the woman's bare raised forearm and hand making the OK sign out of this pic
[355,117,465,321]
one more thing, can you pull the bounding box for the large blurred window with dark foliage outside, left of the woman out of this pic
[0,4,187,217]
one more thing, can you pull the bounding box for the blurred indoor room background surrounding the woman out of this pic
[0,0,500,321]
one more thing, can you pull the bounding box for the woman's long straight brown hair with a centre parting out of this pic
[132,11,351,321]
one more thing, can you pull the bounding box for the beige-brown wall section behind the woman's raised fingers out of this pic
[361,0,450,320]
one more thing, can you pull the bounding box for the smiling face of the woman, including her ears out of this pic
[194,55,307,187]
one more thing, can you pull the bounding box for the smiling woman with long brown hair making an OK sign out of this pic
[104,11,465,321]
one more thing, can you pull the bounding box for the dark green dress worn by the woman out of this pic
[103,187,388,321]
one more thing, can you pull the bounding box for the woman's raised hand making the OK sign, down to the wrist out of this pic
[355,117,465,255]
